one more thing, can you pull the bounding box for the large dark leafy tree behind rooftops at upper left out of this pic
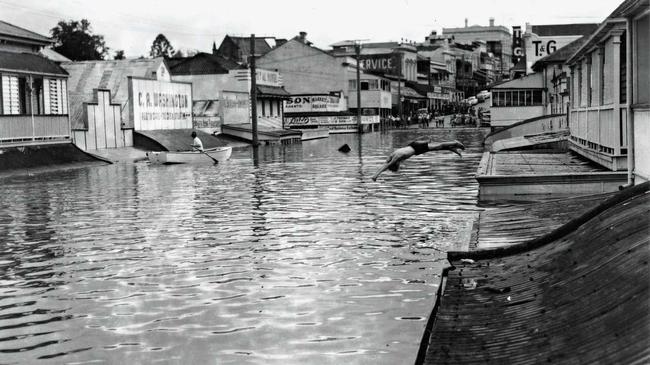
[50,19,108,61]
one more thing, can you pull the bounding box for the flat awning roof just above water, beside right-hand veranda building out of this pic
[476,151,627,200]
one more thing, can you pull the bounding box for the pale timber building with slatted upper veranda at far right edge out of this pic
[567,0,650,184]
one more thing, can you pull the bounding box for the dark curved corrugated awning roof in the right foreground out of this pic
[418,183,650,364]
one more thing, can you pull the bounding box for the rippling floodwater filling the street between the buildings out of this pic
[0,129,483,365]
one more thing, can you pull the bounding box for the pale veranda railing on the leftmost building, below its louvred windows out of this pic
[0,115,70,144]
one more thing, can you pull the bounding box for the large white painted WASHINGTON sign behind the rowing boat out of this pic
[129,78,192,130]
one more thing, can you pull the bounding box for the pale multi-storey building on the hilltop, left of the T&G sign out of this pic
[442,18,513,80]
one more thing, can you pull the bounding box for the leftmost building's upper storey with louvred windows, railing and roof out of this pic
[0,21,71,147]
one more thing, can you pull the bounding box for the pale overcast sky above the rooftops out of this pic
[0,0,622,58]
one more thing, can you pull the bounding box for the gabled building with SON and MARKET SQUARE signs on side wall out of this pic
[256,32,384,133]
